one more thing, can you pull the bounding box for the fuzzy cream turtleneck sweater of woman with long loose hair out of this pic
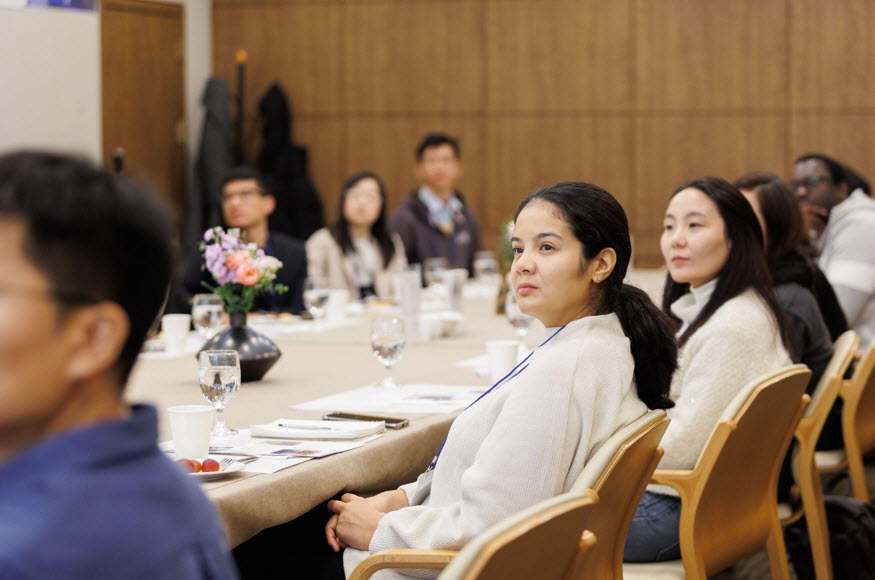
[647,280,792,496]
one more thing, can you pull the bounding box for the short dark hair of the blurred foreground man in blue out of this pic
[0,151,173,388]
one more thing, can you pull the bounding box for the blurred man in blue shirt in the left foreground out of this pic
[0,153,236,580]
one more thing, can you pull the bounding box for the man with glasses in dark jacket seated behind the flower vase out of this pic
[167,166,307,313]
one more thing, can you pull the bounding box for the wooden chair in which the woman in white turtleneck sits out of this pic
[623,365,811,580]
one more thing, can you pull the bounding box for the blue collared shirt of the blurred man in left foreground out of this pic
[0,405,237,580]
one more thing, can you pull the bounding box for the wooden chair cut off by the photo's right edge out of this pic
[815,340,875,502]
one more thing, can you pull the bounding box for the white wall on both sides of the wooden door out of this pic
[0,0,213,165]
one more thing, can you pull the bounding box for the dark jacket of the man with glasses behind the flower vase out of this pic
[167,232,307,314]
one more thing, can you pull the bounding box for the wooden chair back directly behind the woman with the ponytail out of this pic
[572,409,669,580]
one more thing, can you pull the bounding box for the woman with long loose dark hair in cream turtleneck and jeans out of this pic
[624,177,792,562]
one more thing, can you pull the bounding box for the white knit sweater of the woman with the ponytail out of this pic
[344,314,647,580]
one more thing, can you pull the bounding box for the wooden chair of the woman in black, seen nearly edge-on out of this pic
[778,330,860,580]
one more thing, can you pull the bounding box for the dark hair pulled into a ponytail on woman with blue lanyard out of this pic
[514,181,678,409]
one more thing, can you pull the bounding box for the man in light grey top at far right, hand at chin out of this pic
[791,153,875,349]
